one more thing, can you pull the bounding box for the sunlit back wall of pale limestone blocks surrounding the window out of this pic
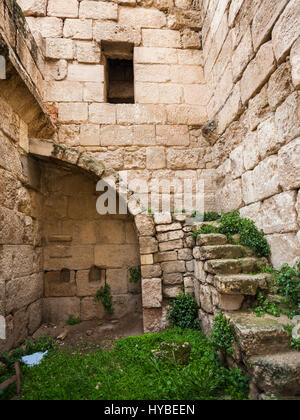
[19,0,215,210]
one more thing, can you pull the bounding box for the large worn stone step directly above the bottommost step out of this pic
[226,312,291,360]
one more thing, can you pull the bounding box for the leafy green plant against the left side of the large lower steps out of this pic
[211,311,235,355]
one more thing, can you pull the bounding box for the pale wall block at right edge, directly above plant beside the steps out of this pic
[267,233,300,270]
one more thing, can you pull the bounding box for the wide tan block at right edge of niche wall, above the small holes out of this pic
[95,244,139,268]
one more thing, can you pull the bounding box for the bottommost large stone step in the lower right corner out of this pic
[247,351,300,399]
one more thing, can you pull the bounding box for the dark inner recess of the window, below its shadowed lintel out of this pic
[107,58,134,104]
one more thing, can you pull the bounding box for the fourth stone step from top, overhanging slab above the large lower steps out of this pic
[213,274,271,296]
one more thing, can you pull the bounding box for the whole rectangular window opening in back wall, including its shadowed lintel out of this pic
[102,43,135,104]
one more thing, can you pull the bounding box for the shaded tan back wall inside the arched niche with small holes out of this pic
[41,163,141,323]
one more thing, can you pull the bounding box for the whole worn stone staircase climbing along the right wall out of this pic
[193,226,300,399]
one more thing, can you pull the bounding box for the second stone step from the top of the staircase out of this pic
[199,245,252,261]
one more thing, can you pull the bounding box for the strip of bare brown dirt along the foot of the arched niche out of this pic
[32,313,143,347]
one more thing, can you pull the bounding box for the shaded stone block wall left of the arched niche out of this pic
[0,97,43,350]
